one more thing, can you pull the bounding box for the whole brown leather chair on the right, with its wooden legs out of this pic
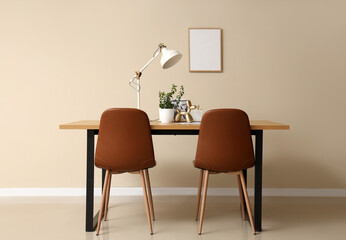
[194,109,256,234]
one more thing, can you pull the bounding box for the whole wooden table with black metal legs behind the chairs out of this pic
[60,120,289,232]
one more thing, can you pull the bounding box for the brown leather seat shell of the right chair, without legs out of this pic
[194,109,255,172]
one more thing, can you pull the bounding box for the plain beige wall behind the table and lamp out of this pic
[0,0,346,188]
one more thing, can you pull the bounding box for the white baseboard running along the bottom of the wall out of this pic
[0,187,346,197]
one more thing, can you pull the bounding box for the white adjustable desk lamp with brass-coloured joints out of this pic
[129,43,183,109]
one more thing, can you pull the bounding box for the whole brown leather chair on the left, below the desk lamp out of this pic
[95,108,156,235]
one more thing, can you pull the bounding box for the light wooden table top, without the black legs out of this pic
[59,120,290,130]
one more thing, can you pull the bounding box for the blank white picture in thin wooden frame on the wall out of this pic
[189,28,222,72]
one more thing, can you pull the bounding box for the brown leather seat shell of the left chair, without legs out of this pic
[95,108,156,172]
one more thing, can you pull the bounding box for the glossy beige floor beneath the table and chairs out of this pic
[0,196,346,240]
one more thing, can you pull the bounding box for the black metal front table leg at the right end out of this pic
[254,130,263,232]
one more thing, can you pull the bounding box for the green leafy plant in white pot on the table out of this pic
[159,84,184,123]
